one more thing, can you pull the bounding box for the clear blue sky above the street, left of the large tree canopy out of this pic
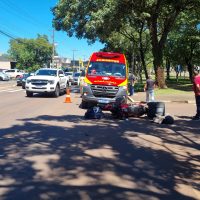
[0,0,103,60]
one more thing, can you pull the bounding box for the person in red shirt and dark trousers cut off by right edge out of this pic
[192,71,200,120]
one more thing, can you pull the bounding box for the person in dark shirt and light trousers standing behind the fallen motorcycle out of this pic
[144,75,155,102]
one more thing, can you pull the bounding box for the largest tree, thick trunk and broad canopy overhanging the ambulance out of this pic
[53,0,200,88]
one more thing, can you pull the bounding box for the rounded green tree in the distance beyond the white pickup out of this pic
[9,35,52,71]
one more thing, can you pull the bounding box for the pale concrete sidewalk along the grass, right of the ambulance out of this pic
[131,92,195,103]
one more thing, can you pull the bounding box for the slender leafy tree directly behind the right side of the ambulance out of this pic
[100,20,150,80]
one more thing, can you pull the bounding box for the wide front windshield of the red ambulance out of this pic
[87,62,126,77]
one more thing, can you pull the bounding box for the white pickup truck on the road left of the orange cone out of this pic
[25,68,68,97]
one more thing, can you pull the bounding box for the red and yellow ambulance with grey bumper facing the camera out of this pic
[82,52,128,108]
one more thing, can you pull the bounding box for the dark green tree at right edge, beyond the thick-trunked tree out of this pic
[167,10,200,80]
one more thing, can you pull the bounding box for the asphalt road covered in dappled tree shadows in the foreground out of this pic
[0,82,200,200]
